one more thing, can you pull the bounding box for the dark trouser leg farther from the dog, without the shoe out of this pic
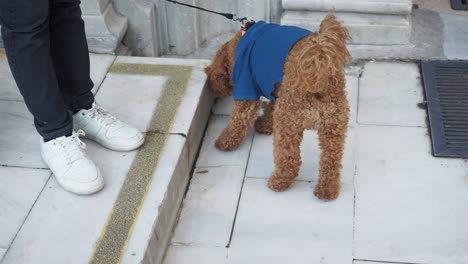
[0,0,72,140]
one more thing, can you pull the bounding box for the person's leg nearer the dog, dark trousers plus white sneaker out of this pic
[50,0,144,151]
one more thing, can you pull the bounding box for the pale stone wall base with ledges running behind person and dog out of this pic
[0,0,412,56]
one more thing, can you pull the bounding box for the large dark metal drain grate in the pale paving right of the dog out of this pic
[422,61,468,158]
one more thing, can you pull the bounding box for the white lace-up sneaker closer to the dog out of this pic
[73,103,145,151]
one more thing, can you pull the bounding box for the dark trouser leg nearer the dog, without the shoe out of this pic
[49,0,94,113]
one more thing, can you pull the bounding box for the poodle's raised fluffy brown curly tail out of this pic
[300,15,351,93]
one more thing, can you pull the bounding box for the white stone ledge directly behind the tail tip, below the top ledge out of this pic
[281,10,411,45]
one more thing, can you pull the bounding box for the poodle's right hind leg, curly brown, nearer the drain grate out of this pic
[314,110,348,200]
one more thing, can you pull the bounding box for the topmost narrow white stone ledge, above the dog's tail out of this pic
[282,0,413,15]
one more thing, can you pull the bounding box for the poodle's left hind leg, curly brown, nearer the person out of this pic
[268,98,304,191]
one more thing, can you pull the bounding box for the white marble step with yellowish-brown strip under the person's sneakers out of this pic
[0,56,212,264]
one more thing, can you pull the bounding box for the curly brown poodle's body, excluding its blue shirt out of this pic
[205,15,351,200]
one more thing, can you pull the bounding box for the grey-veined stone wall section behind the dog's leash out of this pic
[158,0,281,55]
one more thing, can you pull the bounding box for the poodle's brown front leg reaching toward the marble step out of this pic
[215,100,260,150]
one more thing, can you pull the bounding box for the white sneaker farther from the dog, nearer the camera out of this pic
[41,130,104,195]
